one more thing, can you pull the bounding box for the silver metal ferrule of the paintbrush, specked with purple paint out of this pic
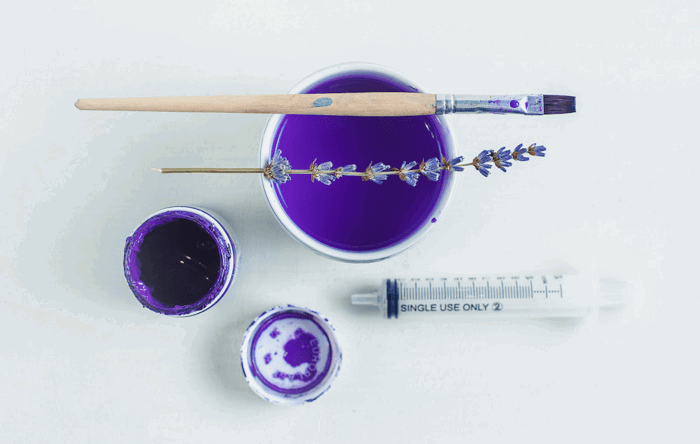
[435,94,545,116]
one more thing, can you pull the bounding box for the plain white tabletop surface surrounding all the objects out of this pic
[0,1,700,443]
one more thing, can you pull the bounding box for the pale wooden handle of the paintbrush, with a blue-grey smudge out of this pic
[75,93,435,116]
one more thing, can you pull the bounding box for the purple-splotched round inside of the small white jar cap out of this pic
[249,310,333,394]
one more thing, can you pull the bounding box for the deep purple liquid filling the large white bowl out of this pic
[270,72,454,252]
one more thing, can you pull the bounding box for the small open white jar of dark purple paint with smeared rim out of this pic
[124,207,237,316]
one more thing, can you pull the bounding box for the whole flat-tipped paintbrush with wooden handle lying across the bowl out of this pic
[75,92,576,116]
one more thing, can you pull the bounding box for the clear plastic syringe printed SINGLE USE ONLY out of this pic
[352,275,624,318]
